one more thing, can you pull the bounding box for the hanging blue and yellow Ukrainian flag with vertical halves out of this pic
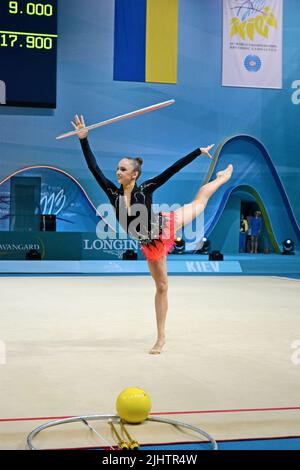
[114,0,178,83]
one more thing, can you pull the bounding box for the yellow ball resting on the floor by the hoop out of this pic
[116,387,151,423]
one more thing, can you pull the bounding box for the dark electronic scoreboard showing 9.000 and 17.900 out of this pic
[0,0,57,108]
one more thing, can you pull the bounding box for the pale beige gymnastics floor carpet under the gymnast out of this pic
[0,276,300,449]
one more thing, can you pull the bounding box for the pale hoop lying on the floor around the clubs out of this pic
[27,414,218,450]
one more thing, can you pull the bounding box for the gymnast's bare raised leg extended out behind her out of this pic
[175,165,233,231]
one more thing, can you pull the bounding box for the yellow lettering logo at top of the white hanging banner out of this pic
[230,0,277,41]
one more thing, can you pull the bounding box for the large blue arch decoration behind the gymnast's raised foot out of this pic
[199,135,300,252]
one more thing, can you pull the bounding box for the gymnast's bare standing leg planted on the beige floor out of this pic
[148,256,168,354]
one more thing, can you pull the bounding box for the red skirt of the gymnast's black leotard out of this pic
[141,212,176,261]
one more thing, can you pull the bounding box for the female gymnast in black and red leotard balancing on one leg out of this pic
[71,115,233,354]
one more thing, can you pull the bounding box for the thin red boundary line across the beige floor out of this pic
[0,406,300,423]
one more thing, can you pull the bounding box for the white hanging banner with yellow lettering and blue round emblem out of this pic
[222,0,282,88]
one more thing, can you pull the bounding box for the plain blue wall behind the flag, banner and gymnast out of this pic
[0,0,300,234]
